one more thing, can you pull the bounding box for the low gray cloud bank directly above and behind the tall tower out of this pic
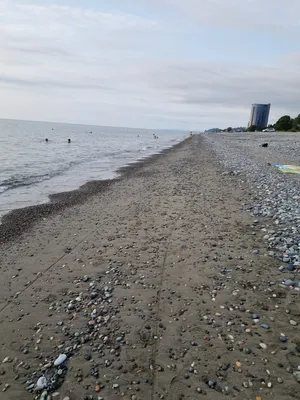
[142,58,300,116]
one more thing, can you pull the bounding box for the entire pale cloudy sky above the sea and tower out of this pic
[0,0,300,131]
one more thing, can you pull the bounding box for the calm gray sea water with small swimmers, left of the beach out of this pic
[0,120,186,216]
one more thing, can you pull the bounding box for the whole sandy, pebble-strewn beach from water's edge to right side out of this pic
[0,133,300,400]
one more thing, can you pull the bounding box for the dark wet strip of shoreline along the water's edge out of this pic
[0,139,188,245]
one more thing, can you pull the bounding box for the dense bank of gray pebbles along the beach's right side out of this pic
[206,132,300,284]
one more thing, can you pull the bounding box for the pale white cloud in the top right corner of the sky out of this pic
[132,0,300,34]
